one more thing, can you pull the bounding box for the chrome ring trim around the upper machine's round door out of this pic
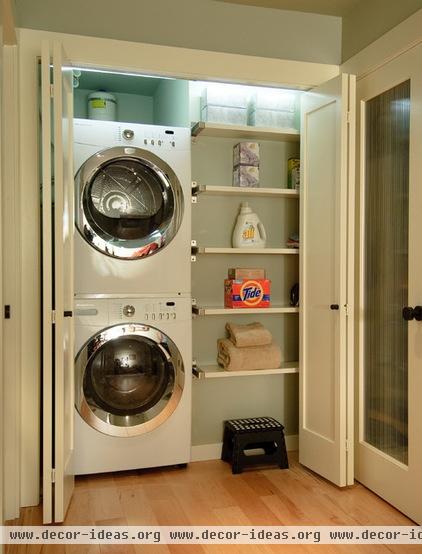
[75,146,184,260]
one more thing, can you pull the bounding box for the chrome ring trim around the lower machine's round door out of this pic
[75,324,185,437]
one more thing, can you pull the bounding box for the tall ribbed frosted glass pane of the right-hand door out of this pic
[364,81,410,464]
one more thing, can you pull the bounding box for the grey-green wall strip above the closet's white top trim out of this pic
[16,0,341,63]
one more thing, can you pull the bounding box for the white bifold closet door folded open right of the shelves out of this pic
[299,74,356,486]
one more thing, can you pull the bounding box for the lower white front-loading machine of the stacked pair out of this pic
[73,297,192,475]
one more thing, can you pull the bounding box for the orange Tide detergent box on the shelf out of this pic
[224,279,271,308]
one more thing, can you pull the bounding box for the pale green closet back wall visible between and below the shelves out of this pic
[192,130,299,445]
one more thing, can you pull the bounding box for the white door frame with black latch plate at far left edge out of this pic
[0,0,22,521]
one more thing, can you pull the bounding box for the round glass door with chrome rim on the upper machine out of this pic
[75,147,183,260]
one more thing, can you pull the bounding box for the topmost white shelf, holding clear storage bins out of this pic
[191,121,300,142]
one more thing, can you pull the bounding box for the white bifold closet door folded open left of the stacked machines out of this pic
[41,43,74,523]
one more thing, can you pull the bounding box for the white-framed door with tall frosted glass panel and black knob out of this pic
[356,42,422,523]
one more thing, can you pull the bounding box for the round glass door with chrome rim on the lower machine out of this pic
[75,324,184,437]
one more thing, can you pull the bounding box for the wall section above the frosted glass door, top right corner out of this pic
[342,0,422,62]
